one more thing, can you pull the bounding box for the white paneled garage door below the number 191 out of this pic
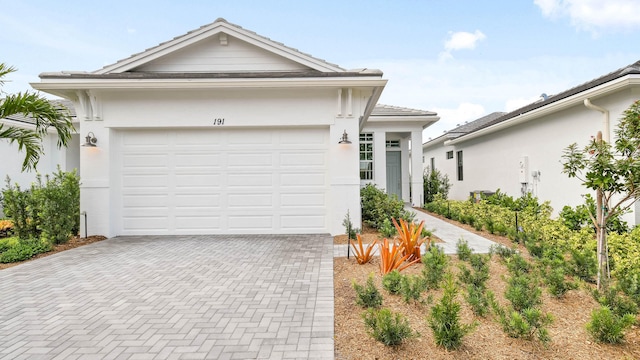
[112,128,328,235]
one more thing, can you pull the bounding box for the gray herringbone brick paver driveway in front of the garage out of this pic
[0,235,333,359]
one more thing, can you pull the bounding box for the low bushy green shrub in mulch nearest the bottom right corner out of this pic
[587,305,636,344]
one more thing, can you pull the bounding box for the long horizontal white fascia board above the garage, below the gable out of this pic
[30,77,387,91]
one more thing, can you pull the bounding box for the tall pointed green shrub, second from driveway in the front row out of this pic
[429,274,476,349]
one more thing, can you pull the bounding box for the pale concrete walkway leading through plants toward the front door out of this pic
[333,206,496,257]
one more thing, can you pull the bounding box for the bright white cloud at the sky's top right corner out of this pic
[534,0,640,33]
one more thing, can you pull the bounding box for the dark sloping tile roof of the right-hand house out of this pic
[471,60,640,132]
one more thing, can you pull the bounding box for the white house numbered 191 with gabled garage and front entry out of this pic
[32,19,437,237]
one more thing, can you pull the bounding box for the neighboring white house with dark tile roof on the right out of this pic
[423,61,640,224]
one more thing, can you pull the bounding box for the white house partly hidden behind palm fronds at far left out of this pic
[0,100,80,188]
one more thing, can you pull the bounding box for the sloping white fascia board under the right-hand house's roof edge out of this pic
[444,75,640,145]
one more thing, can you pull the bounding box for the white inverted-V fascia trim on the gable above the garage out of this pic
[93,23,345,74]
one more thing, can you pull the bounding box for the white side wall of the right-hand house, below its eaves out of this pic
[424,91,635,223]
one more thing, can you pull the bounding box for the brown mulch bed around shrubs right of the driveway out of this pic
[334,209,640,360]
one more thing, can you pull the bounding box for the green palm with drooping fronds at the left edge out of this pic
[0,63,75,171]
